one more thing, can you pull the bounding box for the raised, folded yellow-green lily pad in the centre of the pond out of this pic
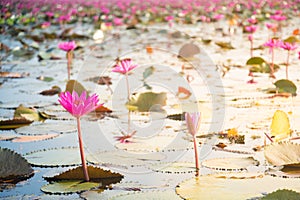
[126,92,167,112]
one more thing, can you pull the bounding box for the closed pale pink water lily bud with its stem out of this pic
[185,112,201,176]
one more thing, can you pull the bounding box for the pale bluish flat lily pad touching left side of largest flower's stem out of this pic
[24,147,81,167]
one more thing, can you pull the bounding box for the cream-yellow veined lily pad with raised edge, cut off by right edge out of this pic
[264,142,300,166]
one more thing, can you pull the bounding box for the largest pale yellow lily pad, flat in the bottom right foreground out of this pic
[176,173,300,200]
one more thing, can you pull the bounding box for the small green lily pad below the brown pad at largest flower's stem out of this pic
[41,180,100,194]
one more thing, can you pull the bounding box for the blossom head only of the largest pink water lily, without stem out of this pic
[58,91,102,117]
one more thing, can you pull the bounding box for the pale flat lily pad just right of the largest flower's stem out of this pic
[87,151,165,166]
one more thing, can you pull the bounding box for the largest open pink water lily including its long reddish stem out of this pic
[58,91,102,181]
